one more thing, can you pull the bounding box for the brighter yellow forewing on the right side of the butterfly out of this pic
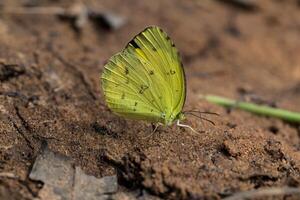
[134,27,186,113]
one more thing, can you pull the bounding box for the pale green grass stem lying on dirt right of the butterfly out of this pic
[201,95,300,123]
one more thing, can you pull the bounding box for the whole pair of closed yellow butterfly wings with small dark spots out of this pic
[101,27,186,124]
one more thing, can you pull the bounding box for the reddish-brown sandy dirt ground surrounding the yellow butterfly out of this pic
[0,0,300,199]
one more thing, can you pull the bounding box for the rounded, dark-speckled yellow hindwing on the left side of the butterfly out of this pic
[102,50,160,121]
